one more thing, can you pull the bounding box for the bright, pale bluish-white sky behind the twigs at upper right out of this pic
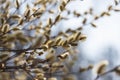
[61,0,120,60]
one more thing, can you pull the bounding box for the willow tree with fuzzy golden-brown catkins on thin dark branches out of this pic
[0,0,120,80]
